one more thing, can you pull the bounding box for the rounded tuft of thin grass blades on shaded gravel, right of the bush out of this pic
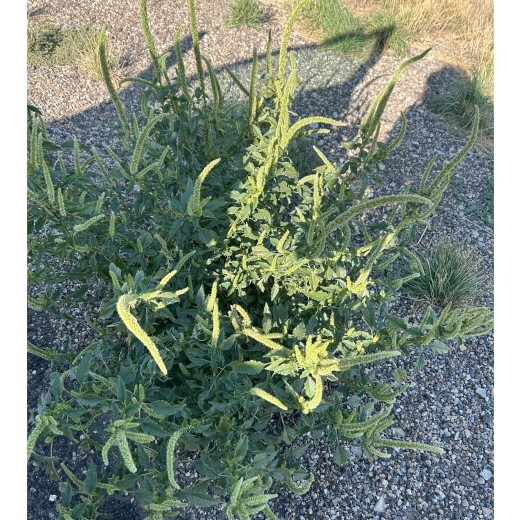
[404,238,485,309]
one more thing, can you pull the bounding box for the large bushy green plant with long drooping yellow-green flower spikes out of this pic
[28,2,491,520]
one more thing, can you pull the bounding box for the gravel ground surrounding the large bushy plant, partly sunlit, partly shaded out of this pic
[28,0,493,520]
